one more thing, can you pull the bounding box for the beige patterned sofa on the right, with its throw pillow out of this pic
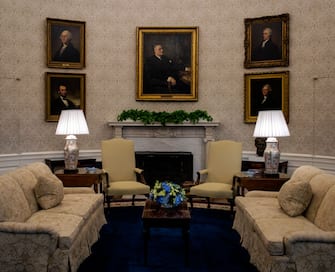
[233,166,335,272]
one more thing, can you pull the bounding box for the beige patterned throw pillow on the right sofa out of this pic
[278,181,313,216]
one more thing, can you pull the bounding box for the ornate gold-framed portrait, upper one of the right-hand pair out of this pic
[244,14,289,68]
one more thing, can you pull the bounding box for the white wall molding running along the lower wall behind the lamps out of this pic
[0,149,335,174]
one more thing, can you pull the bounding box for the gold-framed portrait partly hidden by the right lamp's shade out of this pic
[244,71,289,123]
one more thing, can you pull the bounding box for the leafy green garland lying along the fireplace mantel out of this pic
[117,109,213,126]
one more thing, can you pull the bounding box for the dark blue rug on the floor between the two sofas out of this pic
[78,206,257,272]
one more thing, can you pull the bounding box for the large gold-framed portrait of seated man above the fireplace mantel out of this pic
[136,27,198,101]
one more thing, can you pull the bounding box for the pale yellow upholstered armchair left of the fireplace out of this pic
[101,138,150,208]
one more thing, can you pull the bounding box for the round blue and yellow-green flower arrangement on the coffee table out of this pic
[149,180,186,208]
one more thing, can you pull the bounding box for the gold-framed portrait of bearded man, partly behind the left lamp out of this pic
[45,73,85,122]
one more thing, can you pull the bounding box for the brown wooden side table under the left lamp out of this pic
[55,168,105,193]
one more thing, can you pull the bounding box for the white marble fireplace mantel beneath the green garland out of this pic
[108,122,220,180]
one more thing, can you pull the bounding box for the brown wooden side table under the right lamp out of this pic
[233,172,290,196]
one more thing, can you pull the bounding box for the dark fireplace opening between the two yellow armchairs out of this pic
[135,151,193,187]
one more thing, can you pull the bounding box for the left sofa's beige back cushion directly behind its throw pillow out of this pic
[8,167,39,214]
